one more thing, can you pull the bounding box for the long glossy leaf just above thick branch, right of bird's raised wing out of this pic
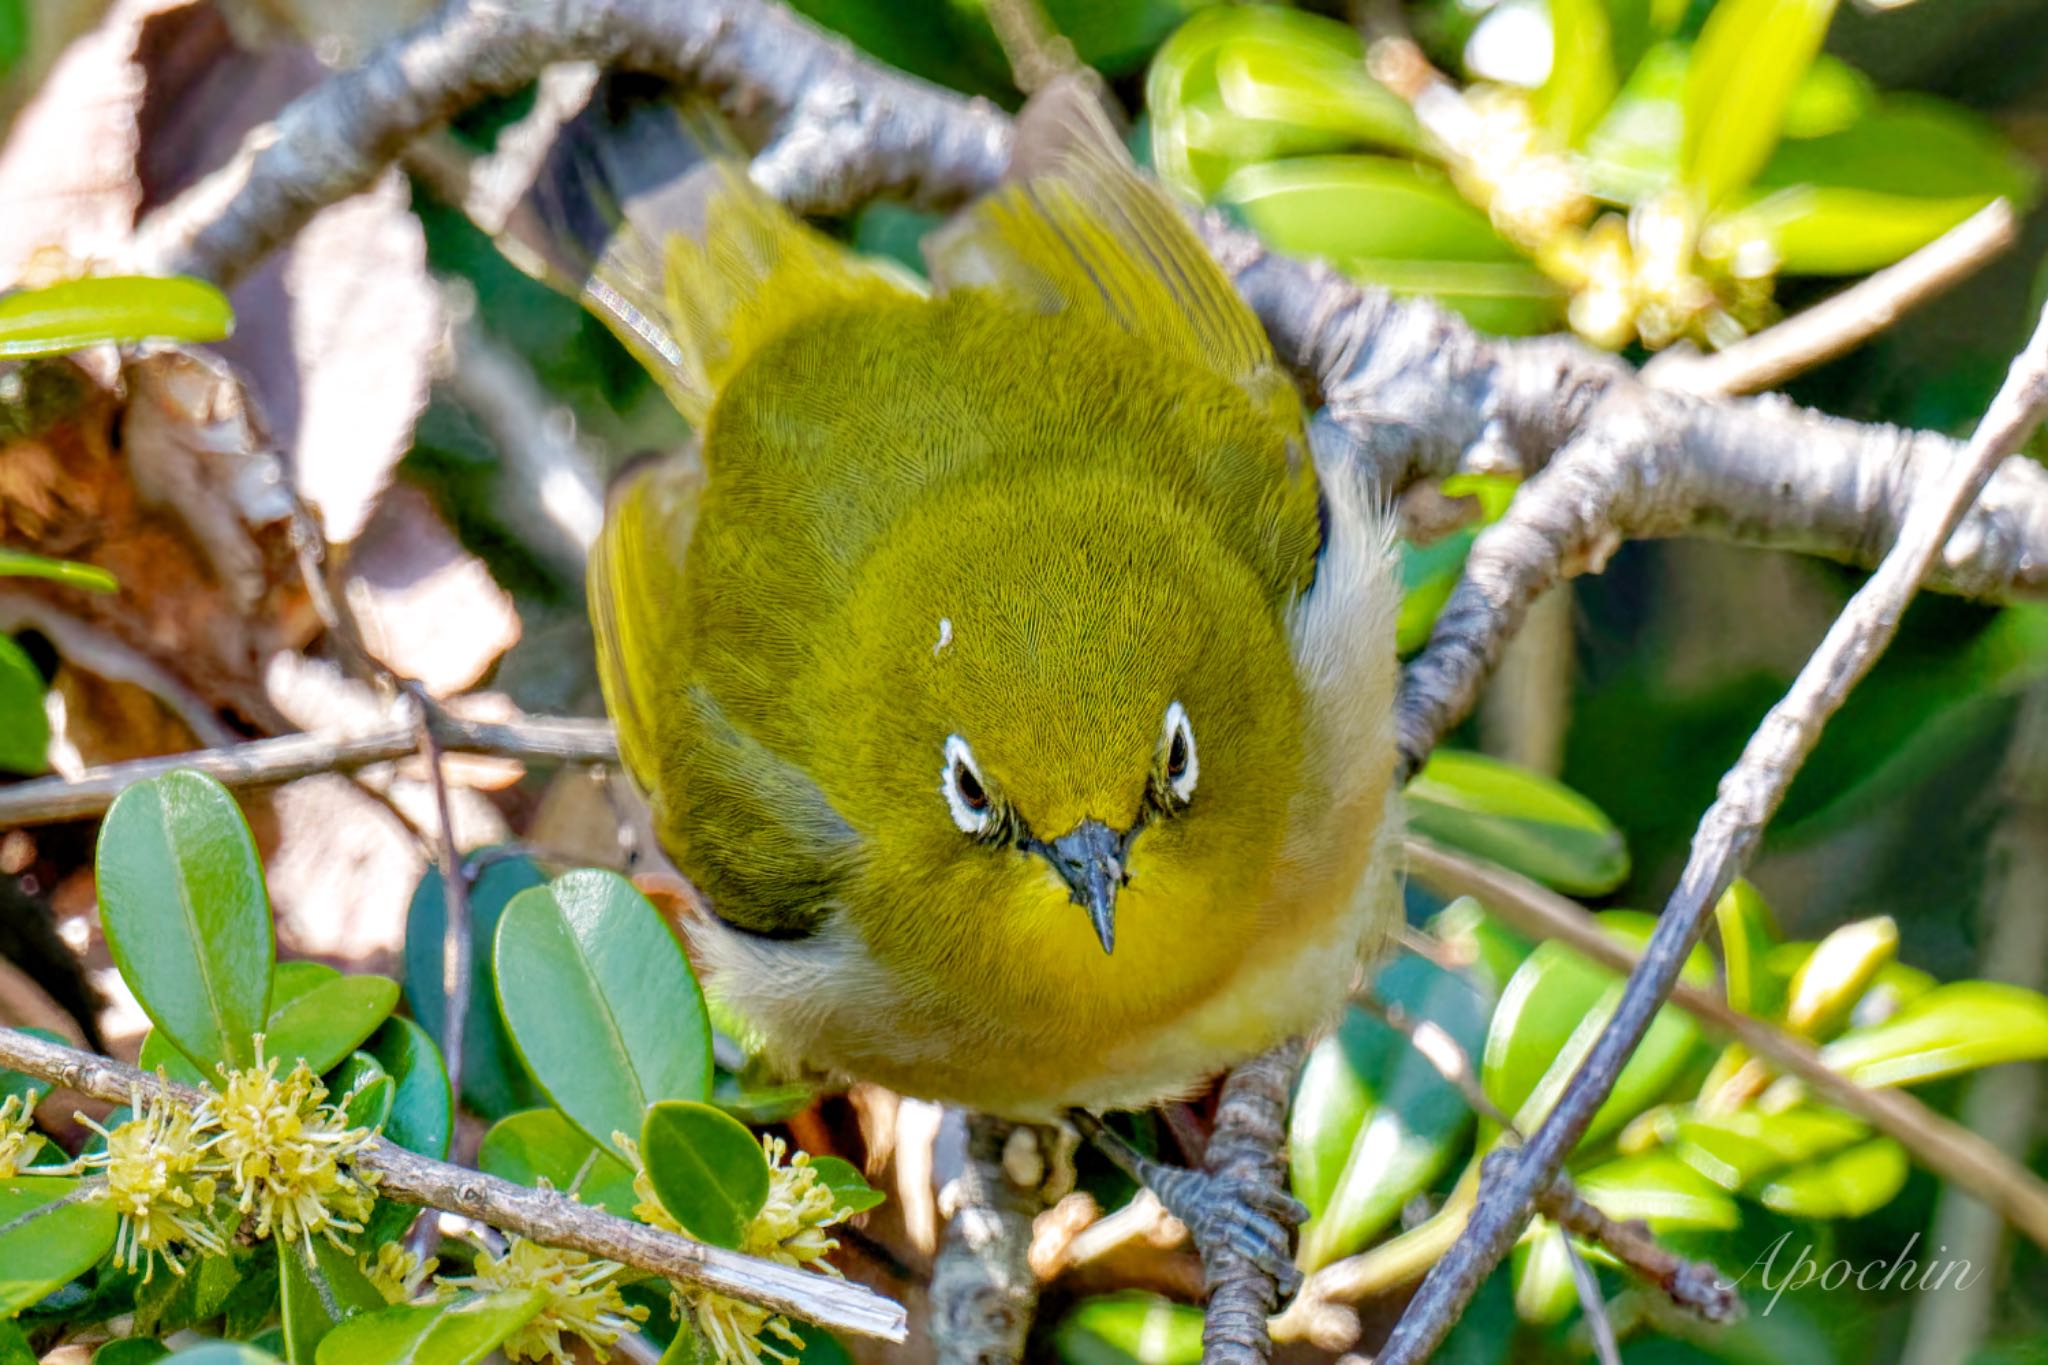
[1217,156,1563,334]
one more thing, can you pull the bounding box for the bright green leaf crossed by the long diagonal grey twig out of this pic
[1481,911,1714,1142]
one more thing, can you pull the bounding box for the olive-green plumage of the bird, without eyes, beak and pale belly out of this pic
[592,144,1391,1111]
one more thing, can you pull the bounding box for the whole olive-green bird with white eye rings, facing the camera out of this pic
[553,90,1399,1273]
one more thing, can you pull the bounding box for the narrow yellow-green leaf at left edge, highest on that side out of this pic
[0,276,236,360]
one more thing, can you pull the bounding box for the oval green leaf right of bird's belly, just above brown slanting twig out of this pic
[1407,749,1628,896]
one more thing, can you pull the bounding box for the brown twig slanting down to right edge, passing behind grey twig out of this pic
[1405,835,2048,1246]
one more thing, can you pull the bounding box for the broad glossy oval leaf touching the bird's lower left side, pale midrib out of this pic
[496,870,711,1146]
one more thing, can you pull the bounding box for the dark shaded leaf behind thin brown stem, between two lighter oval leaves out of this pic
[406,851,547,1117]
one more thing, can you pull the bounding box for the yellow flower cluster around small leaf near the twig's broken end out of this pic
[612,1134,846,1365]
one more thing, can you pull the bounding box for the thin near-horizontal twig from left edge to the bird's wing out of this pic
[0,708,618,829]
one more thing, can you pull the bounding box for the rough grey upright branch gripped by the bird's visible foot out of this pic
[1202,1038,1307,1365]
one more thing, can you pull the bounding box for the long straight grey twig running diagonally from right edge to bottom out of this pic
[1380,300,2048,1365]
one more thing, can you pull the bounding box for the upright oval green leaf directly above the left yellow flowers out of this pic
[96,769,276,1070]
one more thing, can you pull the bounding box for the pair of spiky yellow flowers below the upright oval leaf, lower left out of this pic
[69,1038,375,1281]
